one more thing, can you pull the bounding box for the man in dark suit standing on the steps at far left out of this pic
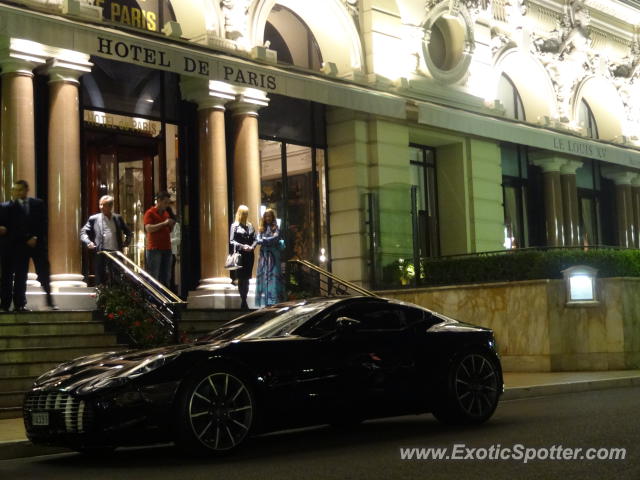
[0,180,56,312]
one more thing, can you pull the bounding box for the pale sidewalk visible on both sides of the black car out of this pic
[5,370,640,460]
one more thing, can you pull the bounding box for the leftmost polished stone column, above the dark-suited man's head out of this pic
[0,53,38,201]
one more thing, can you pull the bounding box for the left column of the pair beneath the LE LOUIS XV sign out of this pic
[533,157,566,247]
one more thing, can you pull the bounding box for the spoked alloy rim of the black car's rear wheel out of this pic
[453,353,498,420]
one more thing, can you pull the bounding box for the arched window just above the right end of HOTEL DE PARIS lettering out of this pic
[264,5,322,71]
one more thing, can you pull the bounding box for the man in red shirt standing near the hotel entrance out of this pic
[144,192,176,287]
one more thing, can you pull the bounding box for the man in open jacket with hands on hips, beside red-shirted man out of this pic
[80,195,131,285]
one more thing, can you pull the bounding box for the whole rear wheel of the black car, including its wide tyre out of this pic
[433,351,500,424]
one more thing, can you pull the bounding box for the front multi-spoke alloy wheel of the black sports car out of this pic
[187,372,254,451]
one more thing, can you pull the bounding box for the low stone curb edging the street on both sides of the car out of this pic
[0,376,640,461]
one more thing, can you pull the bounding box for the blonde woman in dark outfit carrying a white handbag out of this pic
[229,205,257,310]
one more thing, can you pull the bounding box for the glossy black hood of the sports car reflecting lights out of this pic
[33,342,228,394]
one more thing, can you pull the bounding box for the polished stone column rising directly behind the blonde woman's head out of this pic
[229,94,268,228]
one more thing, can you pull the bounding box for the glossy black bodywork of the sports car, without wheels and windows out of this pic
[24,298,502,448]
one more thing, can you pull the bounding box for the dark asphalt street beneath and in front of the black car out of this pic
[0,385,640,480]
